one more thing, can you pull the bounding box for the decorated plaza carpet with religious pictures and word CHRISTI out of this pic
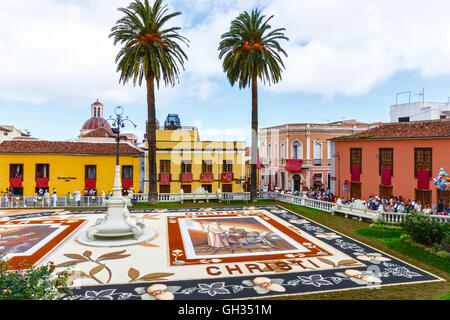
[0,206,443,300]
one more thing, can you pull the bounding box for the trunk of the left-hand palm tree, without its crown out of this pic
[147,68,158,203]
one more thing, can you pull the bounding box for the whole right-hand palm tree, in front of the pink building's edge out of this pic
[219,9,289,201]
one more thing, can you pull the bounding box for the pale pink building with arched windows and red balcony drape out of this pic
[259,120,377,191]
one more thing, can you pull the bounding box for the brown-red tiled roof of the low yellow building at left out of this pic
[0,140,144,155]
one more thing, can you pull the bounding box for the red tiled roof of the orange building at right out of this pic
[330,120,450,141]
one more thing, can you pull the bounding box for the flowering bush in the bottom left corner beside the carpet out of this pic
[0,256,72,300]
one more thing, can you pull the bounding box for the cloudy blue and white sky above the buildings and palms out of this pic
[0,0,450,143]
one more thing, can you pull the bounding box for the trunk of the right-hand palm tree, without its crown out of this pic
[250,70,258,201]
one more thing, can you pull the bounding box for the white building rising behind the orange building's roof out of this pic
[389,101,450,122]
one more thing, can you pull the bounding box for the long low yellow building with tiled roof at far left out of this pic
[0,140,144,196]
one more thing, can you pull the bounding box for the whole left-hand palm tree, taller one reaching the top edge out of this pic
[109,0,188,203]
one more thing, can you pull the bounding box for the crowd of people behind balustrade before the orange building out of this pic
[274,187,450,215]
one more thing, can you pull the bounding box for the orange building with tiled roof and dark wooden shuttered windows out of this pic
[329,120,450,207]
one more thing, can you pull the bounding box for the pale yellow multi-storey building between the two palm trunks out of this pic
[145,116,245,193]
